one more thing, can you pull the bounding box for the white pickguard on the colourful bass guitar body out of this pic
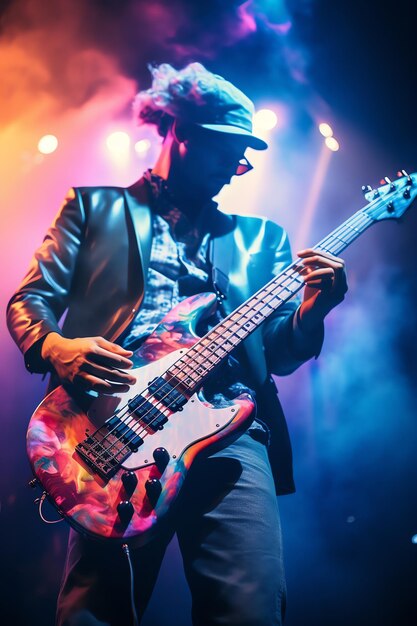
[88,349,237,469]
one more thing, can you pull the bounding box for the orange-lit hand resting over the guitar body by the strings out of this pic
[41,333,136,393]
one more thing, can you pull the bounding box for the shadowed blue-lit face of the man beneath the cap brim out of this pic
[173,127,247,198]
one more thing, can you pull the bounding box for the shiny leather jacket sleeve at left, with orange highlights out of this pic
[7,189,86,372]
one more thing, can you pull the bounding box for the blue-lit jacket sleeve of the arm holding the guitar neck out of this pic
[262,230,324,376]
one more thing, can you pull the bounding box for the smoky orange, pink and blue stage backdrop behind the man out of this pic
[0,0,417,626]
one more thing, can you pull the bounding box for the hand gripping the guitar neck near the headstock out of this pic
[297,248,348,330]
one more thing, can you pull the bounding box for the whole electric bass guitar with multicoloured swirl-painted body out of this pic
[27,172,417,544]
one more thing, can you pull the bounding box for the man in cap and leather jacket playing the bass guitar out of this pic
[8,63,347,626]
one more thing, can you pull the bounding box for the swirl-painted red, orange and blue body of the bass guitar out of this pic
[27,293,254,543]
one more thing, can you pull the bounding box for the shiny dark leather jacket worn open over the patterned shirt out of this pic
[7,179,323,493]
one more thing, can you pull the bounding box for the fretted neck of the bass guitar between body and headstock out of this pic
[167,209,374,393]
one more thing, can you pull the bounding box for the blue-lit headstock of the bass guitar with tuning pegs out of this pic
[362,170,417,222]
